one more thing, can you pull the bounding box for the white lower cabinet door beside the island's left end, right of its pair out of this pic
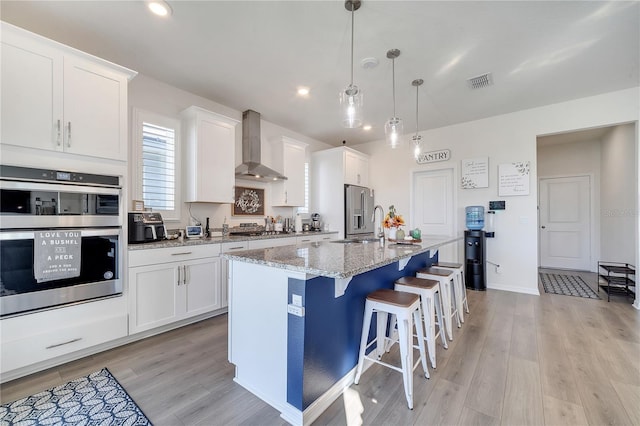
[182,257,222,318]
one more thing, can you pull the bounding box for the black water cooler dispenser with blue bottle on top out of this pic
[464,206,487,291]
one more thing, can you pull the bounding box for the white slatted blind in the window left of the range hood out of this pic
[142,122,176,211]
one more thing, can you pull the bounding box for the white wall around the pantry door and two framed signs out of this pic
[354,88,640,294]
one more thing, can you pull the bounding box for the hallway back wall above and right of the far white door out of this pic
[537,139,604,272]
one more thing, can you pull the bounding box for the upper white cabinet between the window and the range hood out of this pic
[182,106,239,203]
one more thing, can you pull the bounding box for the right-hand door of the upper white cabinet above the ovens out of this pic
[63,56,127,161]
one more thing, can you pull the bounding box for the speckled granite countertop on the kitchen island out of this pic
[223,236,462,278]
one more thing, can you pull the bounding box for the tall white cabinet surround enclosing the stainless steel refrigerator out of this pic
[309,146,369,238]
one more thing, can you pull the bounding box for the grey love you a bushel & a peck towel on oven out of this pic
[33,230,82,283]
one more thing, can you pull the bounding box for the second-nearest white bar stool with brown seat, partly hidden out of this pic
[391,277,449,369]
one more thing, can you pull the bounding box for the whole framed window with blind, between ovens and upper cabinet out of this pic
[131,110,181,220]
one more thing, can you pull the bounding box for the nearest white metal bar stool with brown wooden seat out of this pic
[354,289,429,410]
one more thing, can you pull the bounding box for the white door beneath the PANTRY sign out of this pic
[411,169,458,262]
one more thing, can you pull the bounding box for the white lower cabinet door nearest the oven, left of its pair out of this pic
[129,263,184,333]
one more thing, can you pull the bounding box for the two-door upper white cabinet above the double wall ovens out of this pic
[0,22,135,161]
